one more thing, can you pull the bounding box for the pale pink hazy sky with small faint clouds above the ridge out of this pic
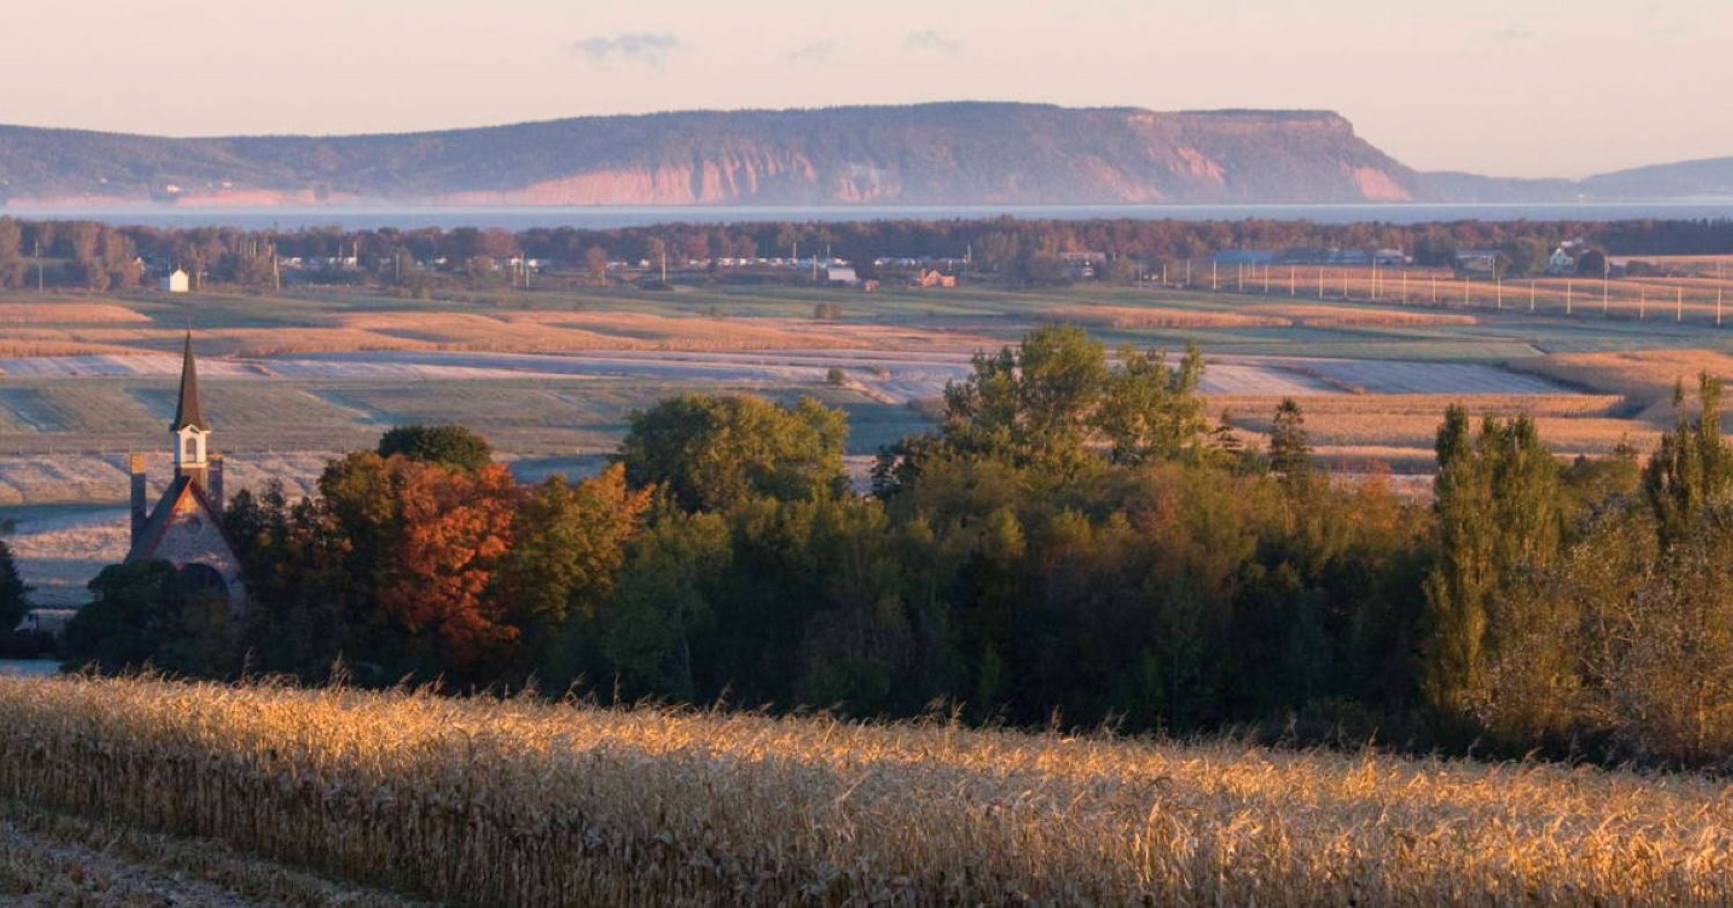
[0,0,1733,177]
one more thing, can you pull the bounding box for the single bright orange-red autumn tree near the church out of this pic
[378,457,520,672]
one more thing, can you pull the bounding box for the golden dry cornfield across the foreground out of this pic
[0,678,1733,906]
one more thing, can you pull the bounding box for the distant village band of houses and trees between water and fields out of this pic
[0,217,1733,295]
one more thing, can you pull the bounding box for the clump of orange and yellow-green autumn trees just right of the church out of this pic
[319,451,652,679]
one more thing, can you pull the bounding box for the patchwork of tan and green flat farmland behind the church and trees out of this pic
[0,284,1733,605]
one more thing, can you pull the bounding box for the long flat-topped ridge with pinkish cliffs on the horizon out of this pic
[0,102,1733,206]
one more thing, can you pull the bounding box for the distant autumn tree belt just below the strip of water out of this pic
[0,217,1733,289]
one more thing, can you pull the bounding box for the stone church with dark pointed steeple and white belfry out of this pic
[127,331,246,610]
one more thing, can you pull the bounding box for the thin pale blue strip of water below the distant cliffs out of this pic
[0,199,1733,230]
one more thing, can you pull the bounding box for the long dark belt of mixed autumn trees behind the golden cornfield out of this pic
[33,326,1733,764]
